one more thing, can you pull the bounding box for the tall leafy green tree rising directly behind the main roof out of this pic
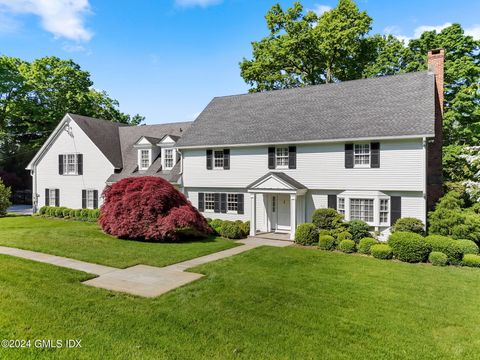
[240,0,375,92]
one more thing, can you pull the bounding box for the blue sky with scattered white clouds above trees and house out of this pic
[0,0,480,123]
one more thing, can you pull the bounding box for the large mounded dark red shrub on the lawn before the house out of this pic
[99,176,211,241]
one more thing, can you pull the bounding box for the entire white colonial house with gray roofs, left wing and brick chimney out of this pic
[28,50,444,239]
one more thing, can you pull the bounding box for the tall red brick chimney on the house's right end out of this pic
[427,49,445,211]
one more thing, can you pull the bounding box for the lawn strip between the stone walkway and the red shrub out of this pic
[0,216,237,268]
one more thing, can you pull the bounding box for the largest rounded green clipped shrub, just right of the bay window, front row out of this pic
[388,231,431,263]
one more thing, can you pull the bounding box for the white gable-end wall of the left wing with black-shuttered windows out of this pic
[29,115,114,209]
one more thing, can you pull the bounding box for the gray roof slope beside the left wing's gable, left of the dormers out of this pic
[68,114,129,169]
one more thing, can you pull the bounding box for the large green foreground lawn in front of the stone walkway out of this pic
[0,247,480,360]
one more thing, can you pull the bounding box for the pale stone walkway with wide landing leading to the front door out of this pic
[0,238,292,297]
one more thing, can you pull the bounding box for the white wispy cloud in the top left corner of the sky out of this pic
[0,0,93,41]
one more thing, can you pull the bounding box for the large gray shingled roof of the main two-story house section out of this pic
[177,71,435,147]
